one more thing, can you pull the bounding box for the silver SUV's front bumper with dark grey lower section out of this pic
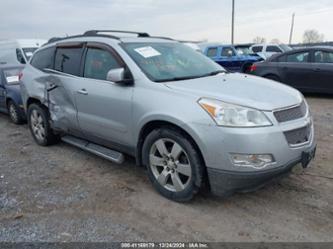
[188,108,316,196]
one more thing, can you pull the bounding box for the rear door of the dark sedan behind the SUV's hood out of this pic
[279,51,313,90]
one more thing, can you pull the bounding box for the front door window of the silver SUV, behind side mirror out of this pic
[84,48,121,80]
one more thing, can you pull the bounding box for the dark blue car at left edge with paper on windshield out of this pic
[0,65,26,124]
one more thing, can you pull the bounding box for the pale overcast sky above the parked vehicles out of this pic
[0,0,333,43]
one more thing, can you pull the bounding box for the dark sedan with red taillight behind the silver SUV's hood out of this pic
[250,47,333,93]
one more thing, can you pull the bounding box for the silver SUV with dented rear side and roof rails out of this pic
[21,30,316,201]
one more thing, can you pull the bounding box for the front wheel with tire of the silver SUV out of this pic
[142,128,204,202]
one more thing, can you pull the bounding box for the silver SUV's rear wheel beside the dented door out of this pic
[27,104,59,146]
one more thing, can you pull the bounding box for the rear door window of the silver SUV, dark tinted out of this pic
[54,47,82,76]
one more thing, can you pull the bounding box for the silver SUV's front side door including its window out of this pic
[75,43,133,146]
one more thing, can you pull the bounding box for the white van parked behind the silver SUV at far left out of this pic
[0,39,47,65]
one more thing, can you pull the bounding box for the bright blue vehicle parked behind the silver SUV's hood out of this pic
[204,45,262,73]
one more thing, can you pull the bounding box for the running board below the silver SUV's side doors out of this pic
[61,136,124,164]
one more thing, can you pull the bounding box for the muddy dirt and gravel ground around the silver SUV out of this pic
[0,96,333,242]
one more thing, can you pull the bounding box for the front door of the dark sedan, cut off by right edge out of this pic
[311,49,333,93]
